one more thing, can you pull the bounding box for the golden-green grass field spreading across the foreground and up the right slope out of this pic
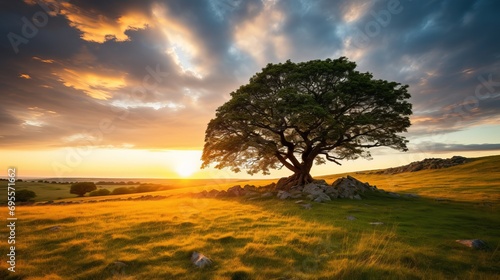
[0,156,500,280]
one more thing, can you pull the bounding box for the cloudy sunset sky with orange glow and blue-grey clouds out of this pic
[0,0,500,178]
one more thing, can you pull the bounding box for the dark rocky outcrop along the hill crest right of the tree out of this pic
[373,156,468,174]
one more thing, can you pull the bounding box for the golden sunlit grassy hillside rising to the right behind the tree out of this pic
[317,155,500,203]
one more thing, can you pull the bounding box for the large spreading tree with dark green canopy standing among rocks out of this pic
[202,57,412,189]
